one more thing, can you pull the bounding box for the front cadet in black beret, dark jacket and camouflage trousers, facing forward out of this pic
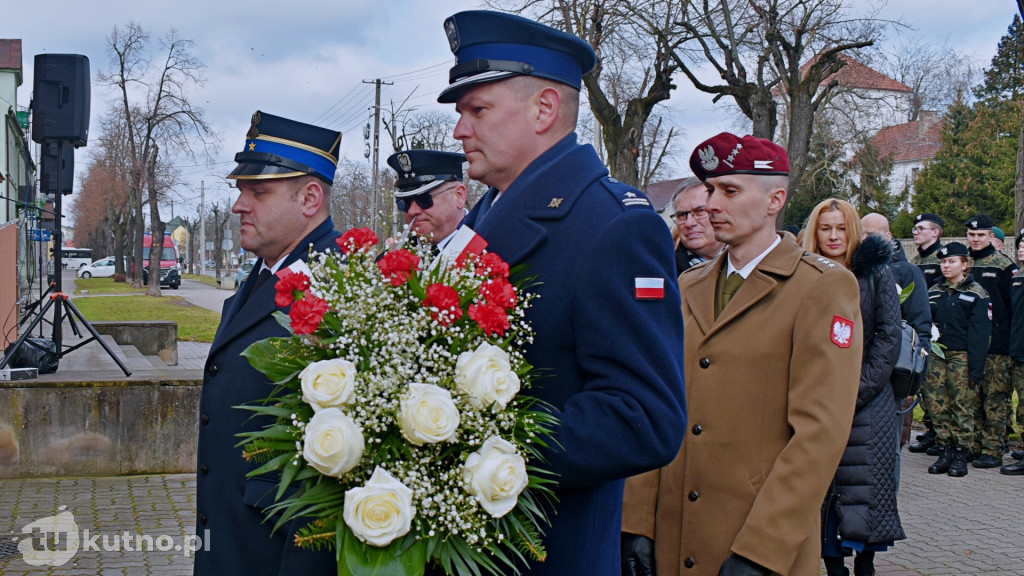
[925,242,992,478]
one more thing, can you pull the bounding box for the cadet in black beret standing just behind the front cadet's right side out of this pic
[964,214,1017,468]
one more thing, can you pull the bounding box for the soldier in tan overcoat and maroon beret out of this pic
[623,133,862,576]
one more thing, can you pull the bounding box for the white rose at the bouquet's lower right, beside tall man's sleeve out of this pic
[462,437,529,518]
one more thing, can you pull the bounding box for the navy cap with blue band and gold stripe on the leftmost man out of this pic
[227,111,341,183]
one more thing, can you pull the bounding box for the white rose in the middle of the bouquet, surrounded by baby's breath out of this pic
[398,382,459,446]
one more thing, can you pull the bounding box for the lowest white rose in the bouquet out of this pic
[344,466,414,546]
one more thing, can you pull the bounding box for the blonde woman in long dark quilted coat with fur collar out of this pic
[804,198,906,576]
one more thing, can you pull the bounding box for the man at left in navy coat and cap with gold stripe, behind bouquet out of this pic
[194,112,341,576]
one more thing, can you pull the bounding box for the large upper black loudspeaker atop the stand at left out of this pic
[32,54,90,148]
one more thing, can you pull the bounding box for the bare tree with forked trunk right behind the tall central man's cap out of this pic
[487,0,689,186]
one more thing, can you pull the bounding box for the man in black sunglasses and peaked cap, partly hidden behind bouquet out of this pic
[387,150,467,249]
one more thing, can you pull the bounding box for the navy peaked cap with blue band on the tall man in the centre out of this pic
[437,10,597,104]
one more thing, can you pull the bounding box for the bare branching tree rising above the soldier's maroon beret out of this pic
[672,0,886,222]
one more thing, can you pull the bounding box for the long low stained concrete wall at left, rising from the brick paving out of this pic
[0,377,203,478]
